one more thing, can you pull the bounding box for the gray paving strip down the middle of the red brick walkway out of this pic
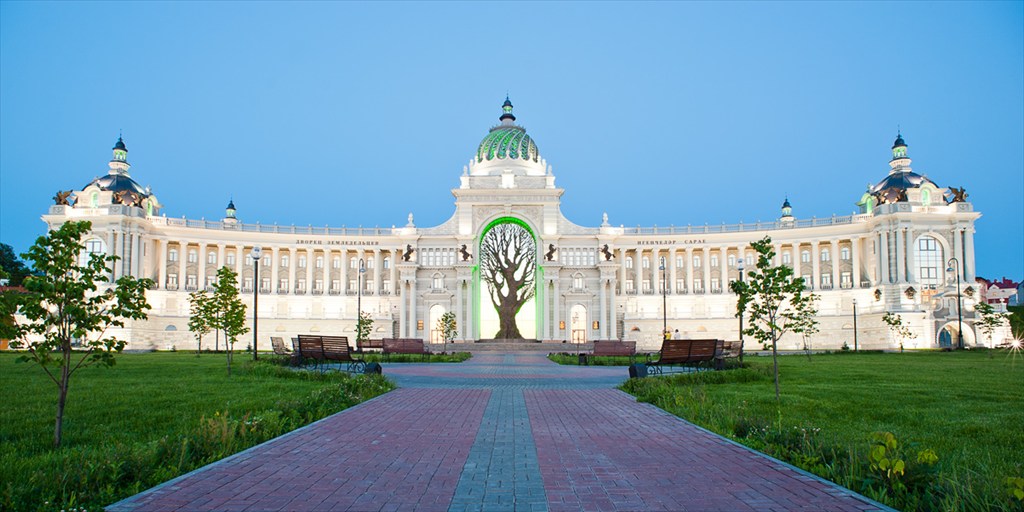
[449,389,548,512]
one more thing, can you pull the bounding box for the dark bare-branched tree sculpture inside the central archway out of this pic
[480,222,537,339]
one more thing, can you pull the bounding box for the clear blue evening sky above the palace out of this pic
[0,1,1024,280]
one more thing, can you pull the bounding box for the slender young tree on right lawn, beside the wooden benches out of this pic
[729,237,817,400]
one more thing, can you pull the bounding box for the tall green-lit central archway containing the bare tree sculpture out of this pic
[474,217,540,339]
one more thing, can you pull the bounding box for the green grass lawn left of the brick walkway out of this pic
[0,352,393,510]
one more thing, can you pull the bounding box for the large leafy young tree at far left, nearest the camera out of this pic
[12,222,153,446]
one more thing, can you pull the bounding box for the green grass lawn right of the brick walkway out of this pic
[623,350,1024,510]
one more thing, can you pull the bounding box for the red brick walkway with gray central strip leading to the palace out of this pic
[108,353,887,512]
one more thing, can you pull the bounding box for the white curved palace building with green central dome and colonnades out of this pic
[43,99,981,350]
